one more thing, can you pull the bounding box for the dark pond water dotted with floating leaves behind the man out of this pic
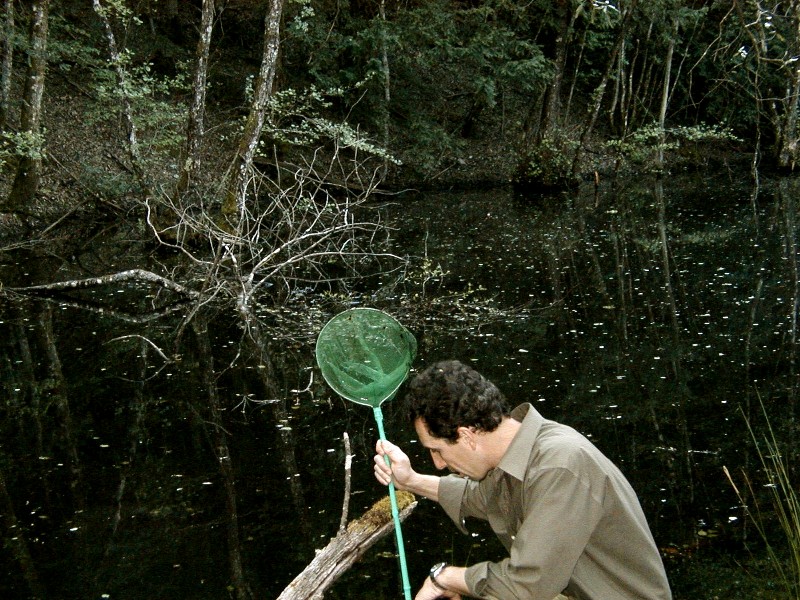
[0,173,800,599]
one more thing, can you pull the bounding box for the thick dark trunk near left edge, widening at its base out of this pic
[8,0,49,212]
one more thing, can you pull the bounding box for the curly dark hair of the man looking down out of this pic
[405,360,510,443]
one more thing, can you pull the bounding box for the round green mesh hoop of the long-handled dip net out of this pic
[316,308,417,408]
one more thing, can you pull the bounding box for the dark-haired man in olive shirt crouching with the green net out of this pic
[374,361,672,600]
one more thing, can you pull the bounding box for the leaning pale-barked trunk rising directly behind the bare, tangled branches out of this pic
[222,0,284,224]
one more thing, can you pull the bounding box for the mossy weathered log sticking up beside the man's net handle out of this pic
[277,492,417,600]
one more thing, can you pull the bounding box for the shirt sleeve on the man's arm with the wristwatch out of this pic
[465,467,602,600]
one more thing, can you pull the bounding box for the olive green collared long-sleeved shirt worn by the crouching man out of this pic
[439,404,672,600]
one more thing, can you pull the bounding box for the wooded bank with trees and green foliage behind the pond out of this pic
[6,0,800,216]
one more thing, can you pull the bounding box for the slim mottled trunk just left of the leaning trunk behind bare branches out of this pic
[177,0,215,196]
